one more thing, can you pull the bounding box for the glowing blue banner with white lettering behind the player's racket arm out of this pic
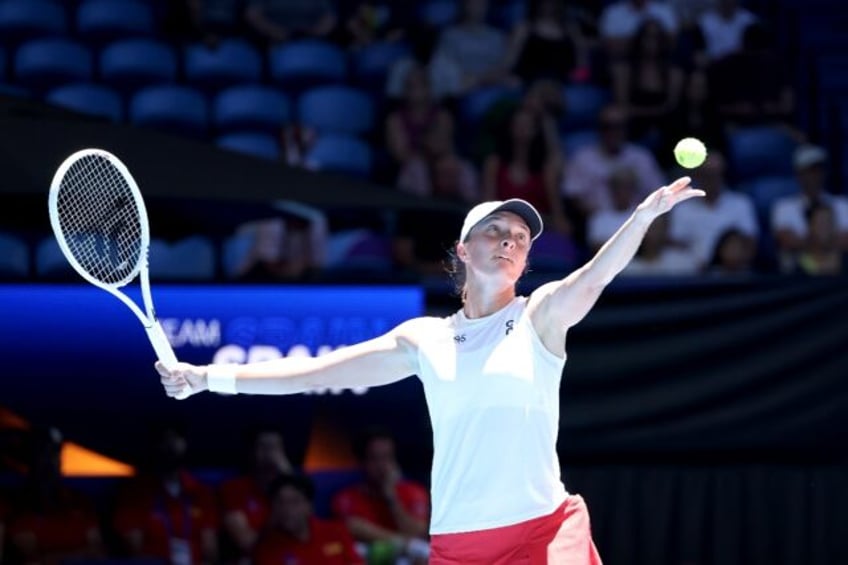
[0,283,426,470]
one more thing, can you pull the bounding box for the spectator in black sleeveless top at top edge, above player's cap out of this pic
[506,0,589,85]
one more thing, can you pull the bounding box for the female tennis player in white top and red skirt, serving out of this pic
[157,177,704,565]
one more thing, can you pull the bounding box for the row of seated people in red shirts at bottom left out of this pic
[0,425,430,565]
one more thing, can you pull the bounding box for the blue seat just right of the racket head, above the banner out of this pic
[150,236,216,280]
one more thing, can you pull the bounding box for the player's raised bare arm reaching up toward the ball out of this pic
[530,177,704,333]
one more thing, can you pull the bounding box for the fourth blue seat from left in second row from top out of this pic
[268,39,348,91]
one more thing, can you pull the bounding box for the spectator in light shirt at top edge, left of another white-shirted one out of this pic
[600,0,679,61]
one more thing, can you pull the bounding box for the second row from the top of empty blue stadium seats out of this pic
[6,38,407,91]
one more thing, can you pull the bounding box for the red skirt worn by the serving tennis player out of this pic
[429,495,602,565]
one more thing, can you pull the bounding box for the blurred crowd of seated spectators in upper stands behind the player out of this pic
[156,0,848,279]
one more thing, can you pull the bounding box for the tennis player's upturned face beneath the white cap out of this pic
[463,212,531,284]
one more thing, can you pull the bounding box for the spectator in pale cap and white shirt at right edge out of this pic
[771,144,848,270]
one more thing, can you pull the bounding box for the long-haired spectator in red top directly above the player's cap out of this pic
[482,108,571,234]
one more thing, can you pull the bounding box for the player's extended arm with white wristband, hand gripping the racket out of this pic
[156,318,423,398]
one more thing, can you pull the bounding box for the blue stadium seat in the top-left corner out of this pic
[0,0,69,47]
